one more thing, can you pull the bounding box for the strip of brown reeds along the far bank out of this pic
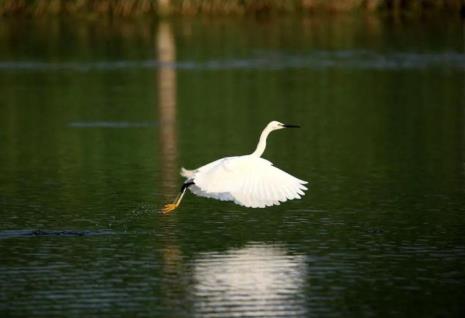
[0,0,465,16]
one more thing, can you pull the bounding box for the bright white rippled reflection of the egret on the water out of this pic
[193,245,307,317]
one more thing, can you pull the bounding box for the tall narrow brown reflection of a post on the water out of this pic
[156,21,178,195]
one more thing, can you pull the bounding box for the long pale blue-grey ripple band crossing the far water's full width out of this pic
[0,50,465,72]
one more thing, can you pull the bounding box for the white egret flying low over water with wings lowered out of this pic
[162,121,307,213]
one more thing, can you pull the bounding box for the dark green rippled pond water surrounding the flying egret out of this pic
[0,17,465,317]
